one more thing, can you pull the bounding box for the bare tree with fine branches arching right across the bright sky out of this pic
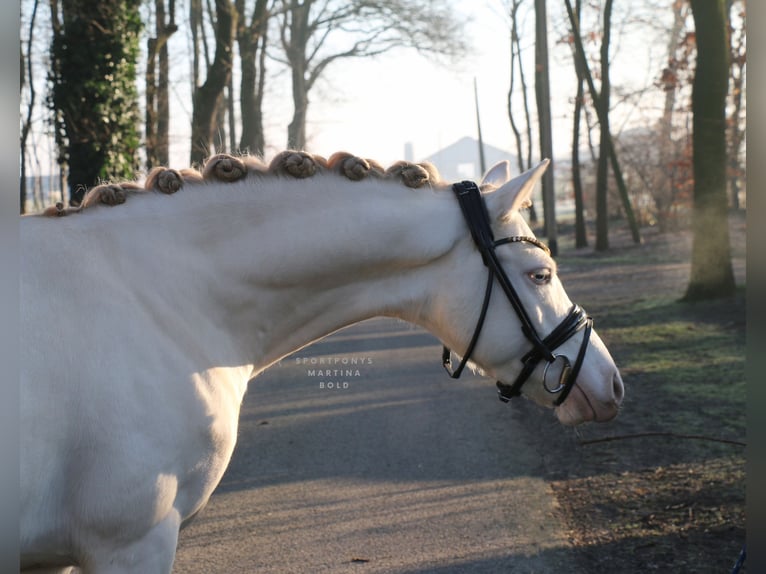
[276,0,465,149]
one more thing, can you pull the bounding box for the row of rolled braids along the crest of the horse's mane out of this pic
[41,150,444,217]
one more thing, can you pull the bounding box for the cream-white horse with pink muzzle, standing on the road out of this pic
[20,151,623,574]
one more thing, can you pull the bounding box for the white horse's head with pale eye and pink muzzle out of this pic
[426,161,624,425]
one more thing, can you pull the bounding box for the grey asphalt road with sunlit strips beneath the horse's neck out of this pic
[174,319,584,574]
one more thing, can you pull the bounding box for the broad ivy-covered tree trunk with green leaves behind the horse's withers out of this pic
[49,0,141,205]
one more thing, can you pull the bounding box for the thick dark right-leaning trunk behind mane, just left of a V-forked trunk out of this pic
[190,0,234,165]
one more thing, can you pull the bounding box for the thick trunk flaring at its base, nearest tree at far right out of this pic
[684,0,735,300]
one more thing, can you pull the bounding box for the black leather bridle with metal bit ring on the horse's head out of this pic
[442,181,593,405]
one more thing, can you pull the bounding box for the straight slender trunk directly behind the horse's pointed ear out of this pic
[535,0,558,256]
